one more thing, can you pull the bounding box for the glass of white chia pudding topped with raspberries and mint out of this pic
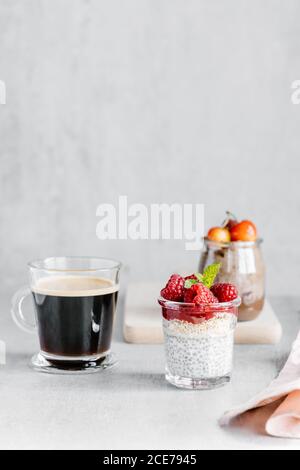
[158,264,240,389]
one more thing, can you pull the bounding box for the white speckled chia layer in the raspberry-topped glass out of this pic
[163,314,236,379]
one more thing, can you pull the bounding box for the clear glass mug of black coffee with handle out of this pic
[12,257,121,373]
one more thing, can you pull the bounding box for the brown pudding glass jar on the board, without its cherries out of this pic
[199,239,265,321]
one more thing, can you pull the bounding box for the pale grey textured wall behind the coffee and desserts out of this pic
[0,0,300,293]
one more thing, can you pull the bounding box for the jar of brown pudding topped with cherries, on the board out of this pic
[199,213,265,321]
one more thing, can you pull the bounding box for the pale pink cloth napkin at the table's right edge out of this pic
[219,332,300,438]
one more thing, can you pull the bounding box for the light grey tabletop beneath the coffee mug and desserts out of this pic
[0,295,300,449]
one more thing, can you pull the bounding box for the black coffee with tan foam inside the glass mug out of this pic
[32,276,118,360]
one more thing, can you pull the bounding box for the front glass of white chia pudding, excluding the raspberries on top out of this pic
[158,297,241,390]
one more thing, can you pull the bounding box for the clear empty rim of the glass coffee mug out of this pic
[27,256,122,272]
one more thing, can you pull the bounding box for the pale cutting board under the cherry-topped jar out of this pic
[124,282,282,344]
